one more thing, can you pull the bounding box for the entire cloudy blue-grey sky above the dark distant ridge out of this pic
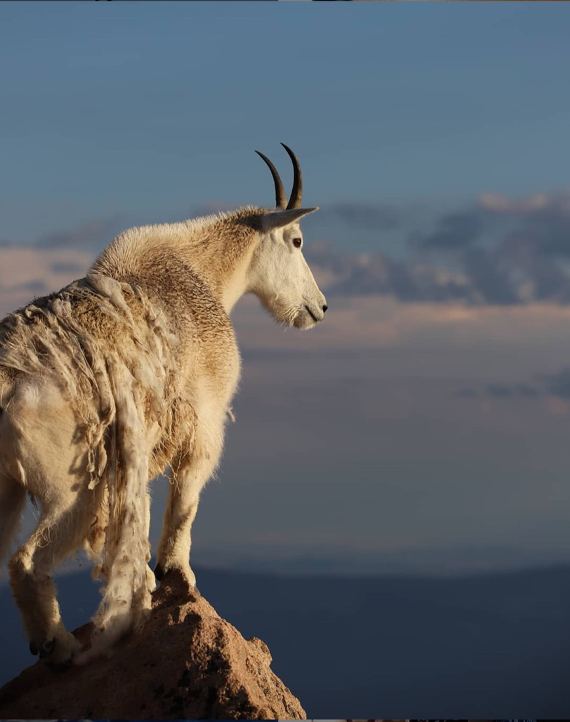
[0,2,570,571]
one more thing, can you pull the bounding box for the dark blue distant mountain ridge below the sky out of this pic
[0,566,570,719]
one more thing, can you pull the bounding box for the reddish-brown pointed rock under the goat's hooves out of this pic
[0,572,306,719]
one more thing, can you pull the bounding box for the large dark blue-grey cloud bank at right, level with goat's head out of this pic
[388,190,570,305]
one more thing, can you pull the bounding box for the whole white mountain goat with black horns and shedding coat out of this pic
[0,146,327,664]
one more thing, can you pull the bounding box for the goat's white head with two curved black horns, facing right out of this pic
[249,143,327,328]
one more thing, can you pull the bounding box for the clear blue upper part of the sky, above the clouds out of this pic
[0,2,570,243]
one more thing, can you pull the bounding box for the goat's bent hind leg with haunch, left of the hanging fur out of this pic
[1,378,103,663]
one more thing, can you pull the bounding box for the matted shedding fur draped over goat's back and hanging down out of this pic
[0,274,195,651]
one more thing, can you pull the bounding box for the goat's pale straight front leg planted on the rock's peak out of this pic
[154,430,222,588]
